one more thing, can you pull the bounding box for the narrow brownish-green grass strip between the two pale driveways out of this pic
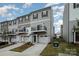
[10,42,33,52]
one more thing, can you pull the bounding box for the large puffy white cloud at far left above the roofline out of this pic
[0,5,21,19]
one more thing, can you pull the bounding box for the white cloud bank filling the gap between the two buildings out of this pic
[45,3,64,34]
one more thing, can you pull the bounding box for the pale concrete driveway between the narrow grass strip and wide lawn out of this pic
[21,43,47,56]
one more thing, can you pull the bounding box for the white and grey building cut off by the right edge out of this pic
[63,3,79,43]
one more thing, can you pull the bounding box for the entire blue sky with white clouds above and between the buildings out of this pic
[0,3,64,33]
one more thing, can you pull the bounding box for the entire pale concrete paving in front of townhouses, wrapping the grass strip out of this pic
[0,43,47,56]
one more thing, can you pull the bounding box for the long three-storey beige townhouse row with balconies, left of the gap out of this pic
[0,7,53,43]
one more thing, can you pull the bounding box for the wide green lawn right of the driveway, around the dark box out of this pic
[40,42,79,56]
